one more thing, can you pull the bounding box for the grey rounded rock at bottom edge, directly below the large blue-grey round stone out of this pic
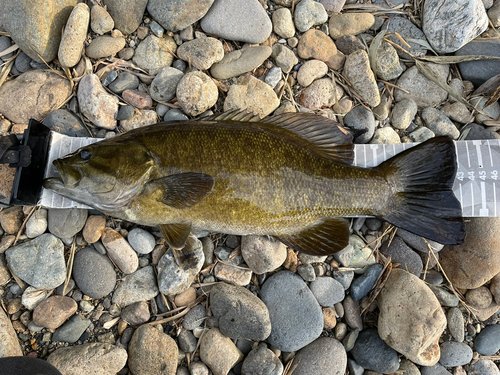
[292,337,347,375]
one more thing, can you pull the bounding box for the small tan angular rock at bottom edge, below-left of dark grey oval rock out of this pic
[200,328,243,375]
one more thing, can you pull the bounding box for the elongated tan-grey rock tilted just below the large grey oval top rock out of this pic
[210,46,272,79]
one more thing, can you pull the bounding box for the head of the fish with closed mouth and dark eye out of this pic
[44,142,155,211]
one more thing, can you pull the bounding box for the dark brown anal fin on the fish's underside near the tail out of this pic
[277,218,349,256]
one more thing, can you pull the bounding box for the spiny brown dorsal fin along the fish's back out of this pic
[202,110,354,165]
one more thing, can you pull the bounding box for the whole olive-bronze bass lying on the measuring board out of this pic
[44,112,465,264]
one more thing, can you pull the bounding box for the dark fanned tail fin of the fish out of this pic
[377,137,465,245]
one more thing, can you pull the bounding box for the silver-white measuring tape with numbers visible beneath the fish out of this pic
[39,132,500,217]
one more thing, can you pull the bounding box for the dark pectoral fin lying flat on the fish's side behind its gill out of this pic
[148,172,215,210]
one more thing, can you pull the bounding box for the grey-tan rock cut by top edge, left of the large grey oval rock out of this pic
[148,0,214,31]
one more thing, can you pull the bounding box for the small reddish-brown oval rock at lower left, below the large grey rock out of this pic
[33,296,78,329]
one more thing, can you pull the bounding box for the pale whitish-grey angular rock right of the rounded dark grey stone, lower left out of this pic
[112,266,158,307]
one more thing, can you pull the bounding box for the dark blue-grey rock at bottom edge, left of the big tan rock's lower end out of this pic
[351,328,399,373]
